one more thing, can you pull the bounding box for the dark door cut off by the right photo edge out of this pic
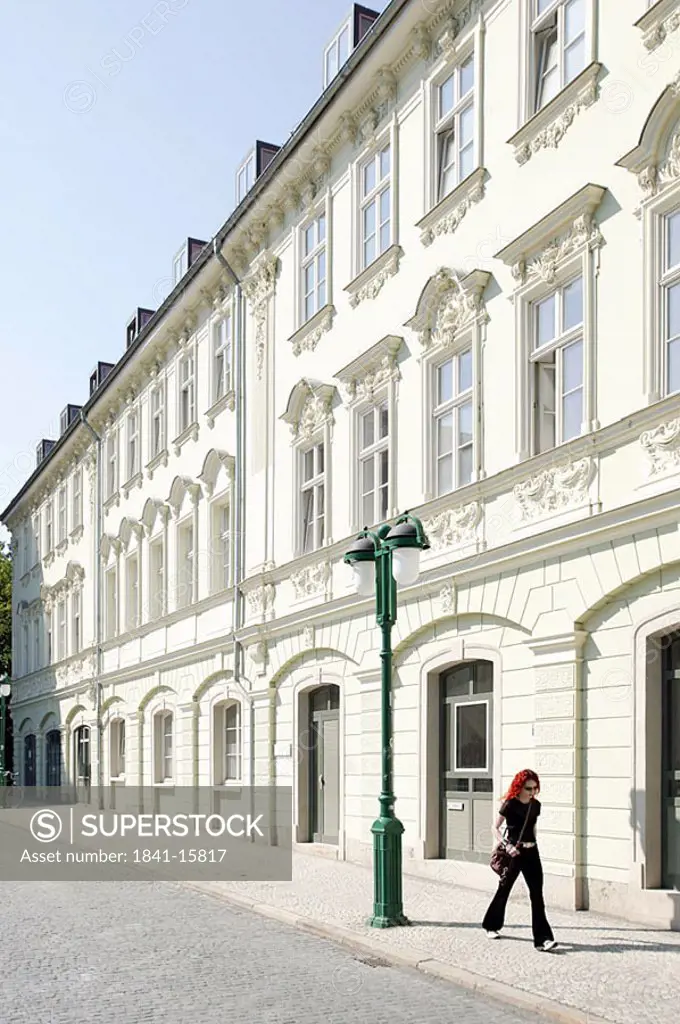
[662,636,680,891]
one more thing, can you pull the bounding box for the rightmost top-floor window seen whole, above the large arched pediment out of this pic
[434,55,475,201]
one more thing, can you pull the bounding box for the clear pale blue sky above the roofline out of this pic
[0,0,387,540]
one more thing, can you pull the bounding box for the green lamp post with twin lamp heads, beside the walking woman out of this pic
[343,512,430,928]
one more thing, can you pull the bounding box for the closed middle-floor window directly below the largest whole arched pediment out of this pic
[433,348,473,495]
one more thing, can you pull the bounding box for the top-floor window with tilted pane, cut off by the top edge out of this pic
[530,0,586,111]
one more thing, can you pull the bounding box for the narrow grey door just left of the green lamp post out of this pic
[309,686,340,844]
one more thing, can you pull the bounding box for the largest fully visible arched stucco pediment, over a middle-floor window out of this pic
[405,266,491,349]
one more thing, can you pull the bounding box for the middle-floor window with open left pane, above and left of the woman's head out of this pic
[530,276,584,455]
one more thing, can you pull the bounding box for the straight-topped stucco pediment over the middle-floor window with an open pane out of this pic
[496,184,606,288]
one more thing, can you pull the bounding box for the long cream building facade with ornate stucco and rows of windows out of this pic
[4,0,680,928]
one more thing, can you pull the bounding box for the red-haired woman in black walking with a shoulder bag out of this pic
[481,768,557,951]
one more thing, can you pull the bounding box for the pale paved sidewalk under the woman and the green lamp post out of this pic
[189,852,680,1024]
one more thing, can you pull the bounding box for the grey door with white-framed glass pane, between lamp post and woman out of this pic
[439,662,494,861]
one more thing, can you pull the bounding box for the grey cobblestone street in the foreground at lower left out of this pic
[5,883,538,1024]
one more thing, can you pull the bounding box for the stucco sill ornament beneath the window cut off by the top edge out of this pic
[508,60,602,164]
